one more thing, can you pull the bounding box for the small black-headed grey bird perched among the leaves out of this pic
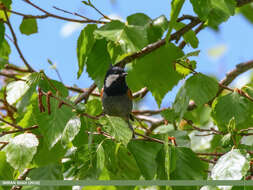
[101,66,134,137]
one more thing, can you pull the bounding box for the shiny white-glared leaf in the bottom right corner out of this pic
[211,149,250,180]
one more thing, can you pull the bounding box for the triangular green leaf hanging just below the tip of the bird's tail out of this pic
[128,140,162,180]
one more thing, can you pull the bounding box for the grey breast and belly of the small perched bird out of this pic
[102,93,133,117]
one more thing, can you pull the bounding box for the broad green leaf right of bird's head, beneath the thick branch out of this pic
[127,44,183,106]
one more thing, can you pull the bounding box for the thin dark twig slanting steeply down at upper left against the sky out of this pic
[3,8,34,72]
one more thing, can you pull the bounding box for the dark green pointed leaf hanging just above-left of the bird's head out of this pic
[86,39,111,88]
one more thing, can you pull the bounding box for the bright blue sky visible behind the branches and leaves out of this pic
[7,0,253,108]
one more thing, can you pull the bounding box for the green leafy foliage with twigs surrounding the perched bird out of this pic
[0,0,253,190]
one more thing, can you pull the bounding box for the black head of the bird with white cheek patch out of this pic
[104,66,128,96]
